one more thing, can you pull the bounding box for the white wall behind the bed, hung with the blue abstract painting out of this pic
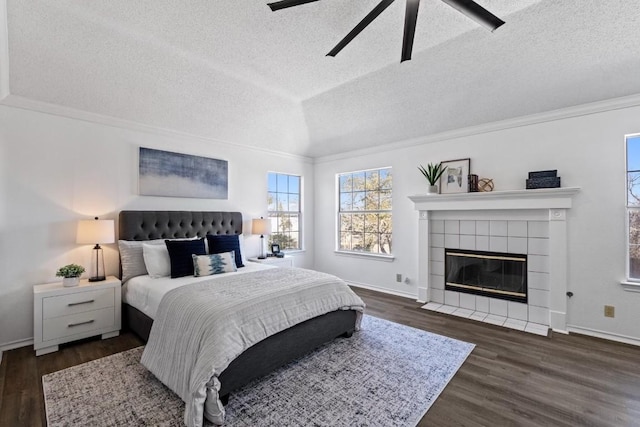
[0,106,313,349]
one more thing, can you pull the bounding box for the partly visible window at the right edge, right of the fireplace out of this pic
[626,134,640,281]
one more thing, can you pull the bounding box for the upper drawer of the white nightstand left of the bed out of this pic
[42,288,115,319]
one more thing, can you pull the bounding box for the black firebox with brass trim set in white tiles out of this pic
[444,248,527,304]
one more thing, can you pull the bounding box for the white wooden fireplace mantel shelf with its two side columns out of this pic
[409,187,580,332]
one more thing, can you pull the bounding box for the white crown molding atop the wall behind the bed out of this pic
[0,94,313,164]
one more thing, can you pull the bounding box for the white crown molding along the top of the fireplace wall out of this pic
[315,94,640,164]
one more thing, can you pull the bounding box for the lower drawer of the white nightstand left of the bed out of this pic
[42,307,115,341]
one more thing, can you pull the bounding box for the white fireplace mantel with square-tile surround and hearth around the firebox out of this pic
[409,187,580,333]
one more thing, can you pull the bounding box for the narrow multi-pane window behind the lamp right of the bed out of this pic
[267,172,302,250]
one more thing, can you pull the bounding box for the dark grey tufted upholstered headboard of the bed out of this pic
[118,211,242,240]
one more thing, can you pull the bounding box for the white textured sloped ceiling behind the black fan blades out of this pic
[0,0,640,157]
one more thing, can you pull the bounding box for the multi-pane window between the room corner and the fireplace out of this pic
[338,168,392,255]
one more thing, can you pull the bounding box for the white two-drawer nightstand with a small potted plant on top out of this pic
[33,276,121,356]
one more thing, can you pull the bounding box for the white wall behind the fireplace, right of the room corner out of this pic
[315,103,640,343]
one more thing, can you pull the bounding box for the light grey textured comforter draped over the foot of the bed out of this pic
[141,268,364,427]
